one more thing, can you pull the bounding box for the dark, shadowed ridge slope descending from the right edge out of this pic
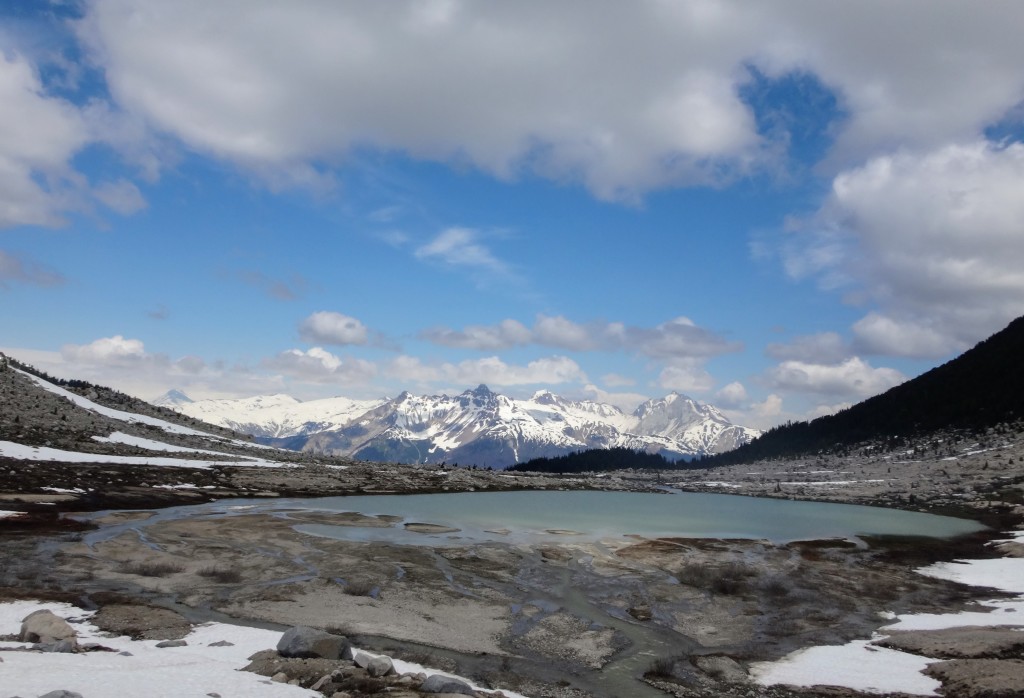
[701,317,1024,466]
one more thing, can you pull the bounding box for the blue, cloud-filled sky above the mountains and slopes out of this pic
[0,0,1024,428]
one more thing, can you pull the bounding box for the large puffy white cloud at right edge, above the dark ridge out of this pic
[786,141,1024,358]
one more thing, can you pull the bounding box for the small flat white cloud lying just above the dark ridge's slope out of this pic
[767,356,906,399]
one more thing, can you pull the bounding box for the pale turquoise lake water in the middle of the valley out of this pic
[274,491,985,546]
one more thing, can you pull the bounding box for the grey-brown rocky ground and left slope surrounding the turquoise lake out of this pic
[0,354,1024,698]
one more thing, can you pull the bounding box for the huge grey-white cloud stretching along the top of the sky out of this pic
[78,0,1024,199]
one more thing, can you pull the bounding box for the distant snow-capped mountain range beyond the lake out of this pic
[158,385,760,468]
